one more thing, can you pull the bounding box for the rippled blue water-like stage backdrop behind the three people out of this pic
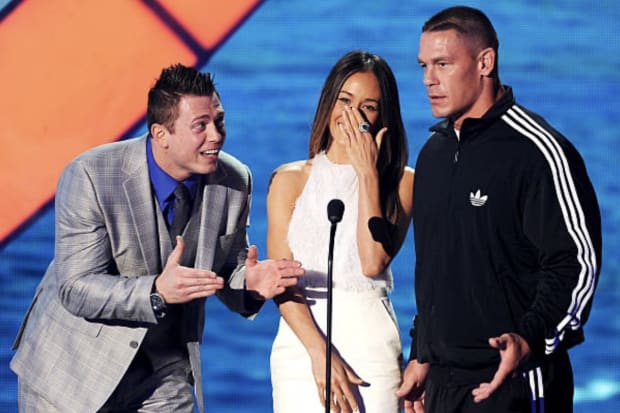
[0,0,620,413]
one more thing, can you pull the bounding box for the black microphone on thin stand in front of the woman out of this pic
[325,199,344,413]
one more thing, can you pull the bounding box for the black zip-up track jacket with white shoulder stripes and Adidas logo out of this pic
[410,86,601,369]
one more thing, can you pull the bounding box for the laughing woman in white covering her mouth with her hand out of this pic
[267,51,414,413]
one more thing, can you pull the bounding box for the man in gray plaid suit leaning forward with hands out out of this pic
[11,64,303,413]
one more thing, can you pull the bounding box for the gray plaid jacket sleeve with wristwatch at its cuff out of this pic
[54,159,156,323]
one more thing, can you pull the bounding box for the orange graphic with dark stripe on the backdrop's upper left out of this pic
[0,0,260,244]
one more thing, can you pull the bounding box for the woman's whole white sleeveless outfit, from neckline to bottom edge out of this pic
[271,152,402,413]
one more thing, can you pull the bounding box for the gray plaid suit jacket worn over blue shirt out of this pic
[11,136,262,413]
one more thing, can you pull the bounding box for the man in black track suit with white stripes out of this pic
[398,6,601,413]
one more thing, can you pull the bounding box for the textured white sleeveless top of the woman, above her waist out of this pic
[288,152,392,291]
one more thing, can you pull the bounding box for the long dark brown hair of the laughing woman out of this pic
[309,51,409,224]
